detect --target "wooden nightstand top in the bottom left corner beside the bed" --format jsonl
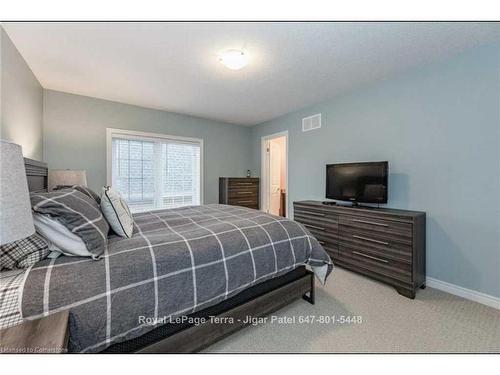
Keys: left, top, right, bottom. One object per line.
{"left": 0, "top": 310, "right": 69, "bottom": 354}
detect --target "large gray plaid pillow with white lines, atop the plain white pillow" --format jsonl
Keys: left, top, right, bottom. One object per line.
{"left": 31, "top": 189, "right": 109, "bottom": 259}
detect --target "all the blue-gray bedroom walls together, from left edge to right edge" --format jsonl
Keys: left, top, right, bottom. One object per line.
{"left": 9, "top": 29, "right": 500, "bottom": 297}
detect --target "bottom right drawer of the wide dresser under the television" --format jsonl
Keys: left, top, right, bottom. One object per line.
{"left": 338, "top": 243, "right": 412, "bottom": 283}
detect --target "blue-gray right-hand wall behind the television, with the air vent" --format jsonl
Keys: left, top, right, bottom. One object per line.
{"left": 252, "top": 45, "right": 500, "bottom": 297}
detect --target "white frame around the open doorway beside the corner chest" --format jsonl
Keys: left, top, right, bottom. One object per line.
{"left": 260, "top": 130, "right": 290, "bottom": 217}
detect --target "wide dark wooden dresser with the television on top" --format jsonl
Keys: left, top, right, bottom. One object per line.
{"left": 293, "top": 201, "right": 425, "bottom": 298}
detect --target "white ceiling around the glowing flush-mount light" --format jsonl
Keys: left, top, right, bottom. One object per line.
{"left": 3, "top": 22, "right": 500, "bottom": 125}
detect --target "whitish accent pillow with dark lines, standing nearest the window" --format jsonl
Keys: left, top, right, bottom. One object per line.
{"left": 101, "top": 186, "right": 134, "bottom": 238}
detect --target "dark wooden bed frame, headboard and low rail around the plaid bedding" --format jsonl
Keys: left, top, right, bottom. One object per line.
{"left": 24, "top": 158, "right": 314, "bottom": 353}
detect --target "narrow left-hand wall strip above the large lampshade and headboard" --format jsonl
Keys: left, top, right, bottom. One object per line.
{"left": 0, "top": 27, "right": 43, "bottom": 160}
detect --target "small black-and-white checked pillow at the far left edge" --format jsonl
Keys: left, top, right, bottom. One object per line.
{"left": 0, "top": 233, "right": 50, "bottom": 270}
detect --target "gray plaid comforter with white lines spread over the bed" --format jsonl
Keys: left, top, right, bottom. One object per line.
{"left": 21, "top": 204, "right": 332, "bottom": 352}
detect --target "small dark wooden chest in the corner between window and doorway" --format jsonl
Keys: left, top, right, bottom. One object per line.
{"left": 219, "top": 177, "right": 259, "bottom": 210}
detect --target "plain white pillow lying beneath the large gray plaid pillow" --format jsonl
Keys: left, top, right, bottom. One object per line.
{"left": 33, "top": 214, "right": 93, "bottom": 257}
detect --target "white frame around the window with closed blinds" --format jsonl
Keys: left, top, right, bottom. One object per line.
{"left": 106, "top": 128, "right": 205, "bottom": 204}
